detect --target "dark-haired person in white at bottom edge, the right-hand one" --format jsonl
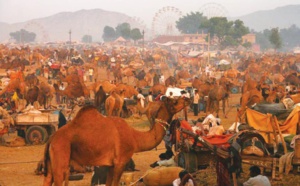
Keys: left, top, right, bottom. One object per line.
{"left": 243, "top": 165, "right": 271, "bottom": 186}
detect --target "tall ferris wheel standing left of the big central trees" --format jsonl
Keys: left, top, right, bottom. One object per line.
{"left": 152, "top": 6, "right": 182, "bottom": 37}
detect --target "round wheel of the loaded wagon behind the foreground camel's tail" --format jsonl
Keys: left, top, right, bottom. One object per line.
{"left": 26, "top": 126, "right": 49, "bottom": 145}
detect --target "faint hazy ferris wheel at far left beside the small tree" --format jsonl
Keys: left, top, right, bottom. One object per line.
{"left": 24, "top": 21, "right": 49, "bottom": 42}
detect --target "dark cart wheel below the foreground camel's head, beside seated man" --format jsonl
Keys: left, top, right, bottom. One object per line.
{"left": 178, "top": 152, "right": 198, "bottom": 173}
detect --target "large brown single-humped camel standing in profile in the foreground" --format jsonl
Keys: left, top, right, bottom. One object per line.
{"left": 44, "top": 98, "right": 190, "bottom": 186}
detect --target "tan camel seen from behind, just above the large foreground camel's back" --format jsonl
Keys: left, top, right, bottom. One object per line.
{"left": 105, "top": 90, "right": 125, "bottom": 117}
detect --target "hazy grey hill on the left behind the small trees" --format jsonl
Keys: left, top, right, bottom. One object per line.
{"left": 0, "top": 9, "right": 146, "bottom": 42}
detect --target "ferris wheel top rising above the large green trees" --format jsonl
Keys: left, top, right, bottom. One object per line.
{"left": 199, "top": 3, "right": 229, "bottom": 19}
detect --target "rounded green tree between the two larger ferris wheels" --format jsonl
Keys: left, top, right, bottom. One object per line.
{"left": 176, "top": 12, "right": 207, "bottom": 34}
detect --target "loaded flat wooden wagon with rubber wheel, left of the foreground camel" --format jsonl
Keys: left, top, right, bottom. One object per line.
{"left": 15, "top": 110, "right": 59, "bottom": 145}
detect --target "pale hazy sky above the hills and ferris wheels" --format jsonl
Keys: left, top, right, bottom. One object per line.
{"left": 0, "top": 0, "right": 300, "bottom": 25}
